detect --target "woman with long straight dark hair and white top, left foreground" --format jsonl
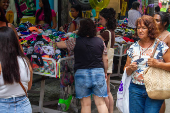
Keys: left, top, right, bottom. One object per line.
{"left": 0, "top": 26, "right": 32, "bottom": 113}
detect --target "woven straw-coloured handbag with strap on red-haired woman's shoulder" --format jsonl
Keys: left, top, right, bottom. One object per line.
{"left": 143, "top": 41, "right": 170, "bottom": 100}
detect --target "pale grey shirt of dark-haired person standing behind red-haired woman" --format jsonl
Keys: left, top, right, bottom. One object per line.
{"left": 128, "top": 9, "right": 141, "bottom": 28}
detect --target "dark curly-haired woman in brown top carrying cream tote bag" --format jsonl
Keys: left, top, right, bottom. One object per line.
{"left": 98, "top": 8, "right": 116, "bottom": 113}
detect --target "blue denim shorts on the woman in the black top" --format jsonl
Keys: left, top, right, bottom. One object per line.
{"left": 74, "top": 68, "right": 108, "bottom": 99}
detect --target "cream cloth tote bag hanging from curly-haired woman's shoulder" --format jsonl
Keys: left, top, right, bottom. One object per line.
{"left": 105, "top": 30, "right": 114, "bottom": 73}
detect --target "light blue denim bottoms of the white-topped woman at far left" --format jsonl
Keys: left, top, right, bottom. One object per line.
{"left": 0, "top": 96, "right": 32, "bottom": 113}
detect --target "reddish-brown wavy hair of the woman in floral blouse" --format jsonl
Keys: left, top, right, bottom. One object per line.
{"left": 135, "top": 15, "right": 159, "bottom": 39}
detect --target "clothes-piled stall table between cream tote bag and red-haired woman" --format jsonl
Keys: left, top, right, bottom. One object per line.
{"left": 112, "top": 18, "right": 135, "bottom": 76}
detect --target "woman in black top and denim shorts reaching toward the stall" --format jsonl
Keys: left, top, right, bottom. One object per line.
{"left": 56, "top": 19, "right": 108, "bottom": 113}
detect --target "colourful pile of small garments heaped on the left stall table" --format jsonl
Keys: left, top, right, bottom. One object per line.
{"left": 16, "top": 22, "right": 76, "bottom": 74}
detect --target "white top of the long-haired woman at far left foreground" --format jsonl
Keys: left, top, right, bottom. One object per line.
{"left": 0, "top": 57, "right": 30, "bottom": 98}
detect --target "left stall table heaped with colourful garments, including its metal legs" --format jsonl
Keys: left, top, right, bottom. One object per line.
{"left": 16, "top": 22, "right": 78, "bottom": 113}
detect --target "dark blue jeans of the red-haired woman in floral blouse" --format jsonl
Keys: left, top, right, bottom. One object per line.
{"left": 129, "top": 83, "right": 164, "bottom": 113}
